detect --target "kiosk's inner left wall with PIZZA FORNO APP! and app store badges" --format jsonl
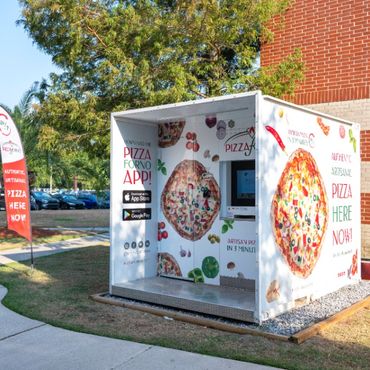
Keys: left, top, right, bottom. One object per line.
{"left": 111, "top": 119, "right": 157, "bottom": 286}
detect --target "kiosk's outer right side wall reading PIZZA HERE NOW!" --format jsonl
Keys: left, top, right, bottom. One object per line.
{"left": 258, "top": 99, "right": 361, "bottom": 320}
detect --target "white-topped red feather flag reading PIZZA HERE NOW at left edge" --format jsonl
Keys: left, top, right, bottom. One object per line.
{"left": 0, "top": 107, "right": 32, "bottom": 242}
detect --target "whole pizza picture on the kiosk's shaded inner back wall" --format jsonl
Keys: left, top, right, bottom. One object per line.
{"left": 161, "top": 160, "right": 220, "bottom": 241}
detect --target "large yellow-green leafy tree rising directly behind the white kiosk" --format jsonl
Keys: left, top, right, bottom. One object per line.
{"left": 20, "top": 0, "right": 303, "bottom": 158}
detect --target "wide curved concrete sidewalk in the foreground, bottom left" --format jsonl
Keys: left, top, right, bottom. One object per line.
{"left": 0, "top": 285, "right": 273, "bottom": 370}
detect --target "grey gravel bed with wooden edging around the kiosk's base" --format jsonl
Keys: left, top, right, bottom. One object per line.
{"left": 103, "top": 280, "right": 370, "bottom": 336}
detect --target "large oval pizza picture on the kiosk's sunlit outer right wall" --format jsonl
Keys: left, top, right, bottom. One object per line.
{"left": 271, "top": 149, "right": 328, "bottom": 278}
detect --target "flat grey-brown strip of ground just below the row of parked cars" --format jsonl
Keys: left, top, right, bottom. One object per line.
{"left": 0, "top": 209, "right": 109, "bottom": 228}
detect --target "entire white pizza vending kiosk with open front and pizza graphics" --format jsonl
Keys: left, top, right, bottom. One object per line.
{"left": 110, "top": 92, "right": 361, "bottom": 322}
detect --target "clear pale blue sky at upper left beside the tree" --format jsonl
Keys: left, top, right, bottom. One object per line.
{"left": 0, "top": 0, "right": 58, "bottom": 109}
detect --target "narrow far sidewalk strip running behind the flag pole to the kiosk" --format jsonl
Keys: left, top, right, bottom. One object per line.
{"left": 0, "top": 233, "right": 109, "bottom": 265}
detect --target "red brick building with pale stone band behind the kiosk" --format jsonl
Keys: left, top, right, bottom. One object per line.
{"left": 261, "top": 0, "right": 370, "bottom": 258}
